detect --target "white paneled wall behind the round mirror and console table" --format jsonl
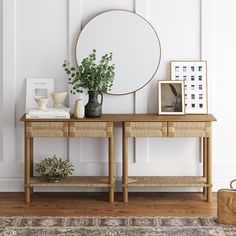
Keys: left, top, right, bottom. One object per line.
{"left": 0, "top": 0, "right": 236, "bottom": 191}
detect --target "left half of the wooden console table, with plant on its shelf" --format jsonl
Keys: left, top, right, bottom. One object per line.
{"left": 20, "top": 116, "right": 114, "bottom": 203}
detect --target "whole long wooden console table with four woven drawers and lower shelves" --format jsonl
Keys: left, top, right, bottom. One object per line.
{"left": 20, "top": 114, "right": 216, "bottom": 203}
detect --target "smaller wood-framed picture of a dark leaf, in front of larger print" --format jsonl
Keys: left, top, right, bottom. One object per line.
{"left": 158, "top": 80, "right": 185, "bottom": 115}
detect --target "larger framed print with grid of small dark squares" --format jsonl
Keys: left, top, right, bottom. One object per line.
{"left": 170, "top": 61, "right": 208, "bottom": 114}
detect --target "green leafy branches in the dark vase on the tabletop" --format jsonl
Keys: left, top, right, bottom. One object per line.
{"left": 63, "top": 49, "right": 115, "bottom": 94}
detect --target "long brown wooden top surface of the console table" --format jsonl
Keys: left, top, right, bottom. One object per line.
{"left": 20, "top": 114, "right": 216, "bottom": 122}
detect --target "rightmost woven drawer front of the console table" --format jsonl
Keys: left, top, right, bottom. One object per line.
{"left": 168, "top": 122, "right": 211, "bottom": 137}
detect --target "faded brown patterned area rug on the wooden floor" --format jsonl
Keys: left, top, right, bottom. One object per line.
{"left": 0, "top": 217, "right": 236, "bottom": 236}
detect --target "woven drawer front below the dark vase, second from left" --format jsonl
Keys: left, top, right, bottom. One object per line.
{"left": 69, "top": 122, "right": 113, "bottom": 137}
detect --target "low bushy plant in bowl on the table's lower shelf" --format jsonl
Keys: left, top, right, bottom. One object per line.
{"left": 36, "top": 155, "right": 74, "bottom": 182}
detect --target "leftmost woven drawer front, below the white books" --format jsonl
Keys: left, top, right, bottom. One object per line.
{"left": 26, "top": 122, "right": 68, "bottom": 137}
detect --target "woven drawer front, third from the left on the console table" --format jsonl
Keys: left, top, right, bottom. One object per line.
{"left": 125, "top": 122, "right": 167, "bottom": 137}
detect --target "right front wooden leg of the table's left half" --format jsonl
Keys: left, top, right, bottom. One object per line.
{"left": 108, "top": 133, "right": 114, "bottom": 202}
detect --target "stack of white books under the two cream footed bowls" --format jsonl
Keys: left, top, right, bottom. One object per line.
{"left": 26, "top": 108, "right": 70, "bottom": 119}
